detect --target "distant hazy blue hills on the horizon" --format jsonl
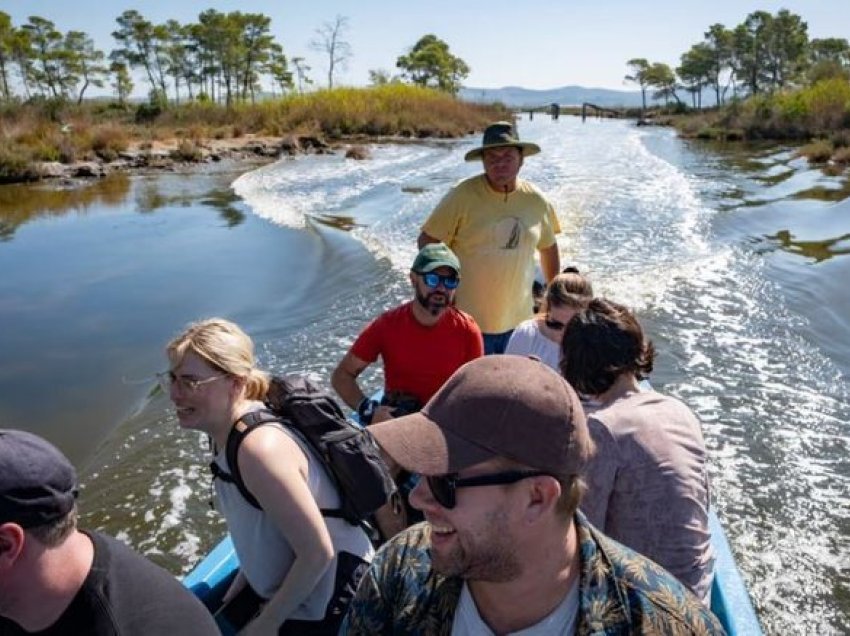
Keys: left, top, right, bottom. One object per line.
{"left": 460, "top": 86, "right": 651, "bottom": 108}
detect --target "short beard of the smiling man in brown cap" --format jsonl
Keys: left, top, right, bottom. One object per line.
{"left": 431, "top": 512, "right": 522, "bottom": 583}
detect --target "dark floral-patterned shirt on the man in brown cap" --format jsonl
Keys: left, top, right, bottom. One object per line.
{"left": 340, "top": 512, "right": 726, "bottom": 636}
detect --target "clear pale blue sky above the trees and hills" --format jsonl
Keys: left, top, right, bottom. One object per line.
{"left": 6, "top": 0, "right": 850, "bottom": 90}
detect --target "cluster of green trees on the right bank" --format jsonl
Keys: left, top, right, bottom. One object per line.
{"left": 625, "top": 9, "right": 850, "bottom": 109}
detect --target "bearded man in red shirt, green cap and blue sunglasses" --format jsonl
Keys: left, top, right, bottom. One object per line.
{"left": 331, "top": 243, "right": 483, "bottom": 424}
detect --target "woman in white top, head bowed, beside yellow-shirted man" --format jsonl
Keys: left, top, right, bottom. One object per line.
{"left": 505, "top": 267, "right": 593, "bottom": 371}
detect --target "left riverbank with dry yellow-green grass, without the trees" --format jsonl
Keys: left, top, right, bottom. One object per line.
{"left": 0, "top": 84, "right": 508, "bottom": 183}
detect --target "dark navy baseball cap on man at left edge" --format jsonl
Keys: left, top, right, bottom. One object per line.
{"left": 0, "top": 429, "right": 77, "bottom": 528}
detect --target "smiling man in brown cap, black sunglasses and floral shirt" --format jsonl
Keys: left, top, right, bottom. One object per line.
{"left": 340, "top": 355, "right": 724, "bottom": 636}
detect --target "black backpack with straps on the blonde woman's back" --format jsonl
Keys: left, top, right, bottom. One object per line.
{"left": 210, "top": 375, "right": 396, "bottom": 525}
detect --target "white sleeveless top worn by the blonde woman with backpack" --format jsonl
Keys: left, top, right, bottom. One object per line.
{"left": 213, "top": 424, "right": 374, "bottom": 620}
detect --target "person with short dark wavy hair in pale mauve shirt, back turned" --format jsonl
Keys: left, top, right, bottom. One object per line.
{"left": 561, "top": 298, "right": 714, "bottom": 604}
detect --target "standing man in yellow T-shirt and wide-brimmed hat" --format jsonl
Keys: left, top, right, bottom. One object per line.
{"left": 419, "top": 121, "right": 561, "bottom": 354}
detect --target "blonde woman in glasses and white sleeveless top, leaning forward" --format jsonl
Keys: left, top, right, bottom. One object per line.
{"left": 162, "top": 318, "right": 373, "bottom": 635}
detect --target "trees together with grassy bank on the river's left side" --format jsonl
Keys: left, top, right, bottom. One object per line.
{"left": 0, "top": 9, "right": 484, "bottom": 181}
